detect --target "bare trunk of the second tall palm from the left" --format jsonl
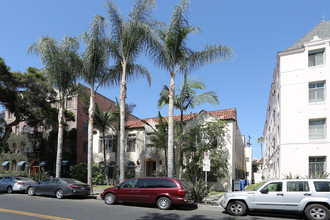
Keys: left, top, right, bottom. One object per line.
{"left": 87, "top": 85, "right": 95, "bottom": 192}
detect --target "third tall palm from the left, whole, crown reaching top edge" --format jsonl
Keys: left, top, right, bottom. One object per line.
{"left": 106, "top": 0, "right": 155, "bottom": 182}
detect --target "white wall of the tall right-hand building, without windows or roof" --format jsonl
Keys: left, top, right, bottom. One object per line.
{"left": 264, "top": 37, "right": 330, "bottom": 179}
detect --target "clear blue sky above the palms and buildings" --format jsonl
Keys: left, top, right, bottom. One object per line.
{"left": 0, "top": 0, "right": 330, "bottom": 158}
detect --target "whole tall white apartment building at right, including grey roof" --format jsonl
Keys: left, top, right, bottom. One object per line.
{"left": 263, "top": 20, "right": 330, "bottom": 180}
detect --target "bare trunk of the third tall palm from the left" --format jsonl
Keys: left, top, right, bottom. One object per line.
{"left": 119, "top": 61, "right": 126, "bottom": 182}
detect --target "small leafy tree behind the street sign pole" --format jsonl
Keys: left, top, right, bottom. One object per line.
{"left": 182, "top": 119, "right": 229, "bottom": 198}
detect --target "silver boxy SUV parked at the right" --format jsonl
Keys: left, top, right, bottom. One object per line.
{"left": 220, "top": 179, "right": 330, "bottom": 220}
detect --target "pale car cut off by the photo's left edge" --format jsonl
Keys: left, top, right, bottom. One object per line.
{"left": 0, "top": 176, "right": 35, "bottom": 193}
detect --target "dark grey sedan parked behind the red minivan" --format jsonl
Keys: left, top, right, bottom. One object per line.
{"left": 27, "top": 178, "right": 90, "bottom": 199}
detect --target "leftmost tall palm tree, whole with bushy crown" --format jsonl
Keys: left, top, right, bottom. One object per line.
{"left": 28, "top": 36, "right": 81, "bottom": 178}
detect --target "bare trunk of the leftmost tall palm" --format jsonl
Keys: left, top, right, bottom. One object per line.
{"left": 56, "top": 103, "right": 64, "bottom": 178}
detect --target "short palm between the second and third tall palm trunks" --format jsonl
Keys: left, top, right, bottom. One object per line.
{"left": 94, "top": 104, "right": 116, "bottom": 185}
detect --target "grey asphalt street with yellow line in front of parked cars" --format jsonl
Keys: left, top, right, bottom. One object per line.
{"left": 0, "top": 193, "right": 303, "bottom": 220}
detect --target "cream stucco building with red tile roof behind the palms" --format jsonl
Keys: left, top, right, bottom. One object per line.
{"left": 93, "top": 108, "right": 248, "bottom": 191}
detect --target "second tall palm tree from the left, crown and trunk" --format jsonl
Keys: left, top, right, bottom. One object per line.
{"left": 82, "top": 15, "right": 116, "bottom": 187}
